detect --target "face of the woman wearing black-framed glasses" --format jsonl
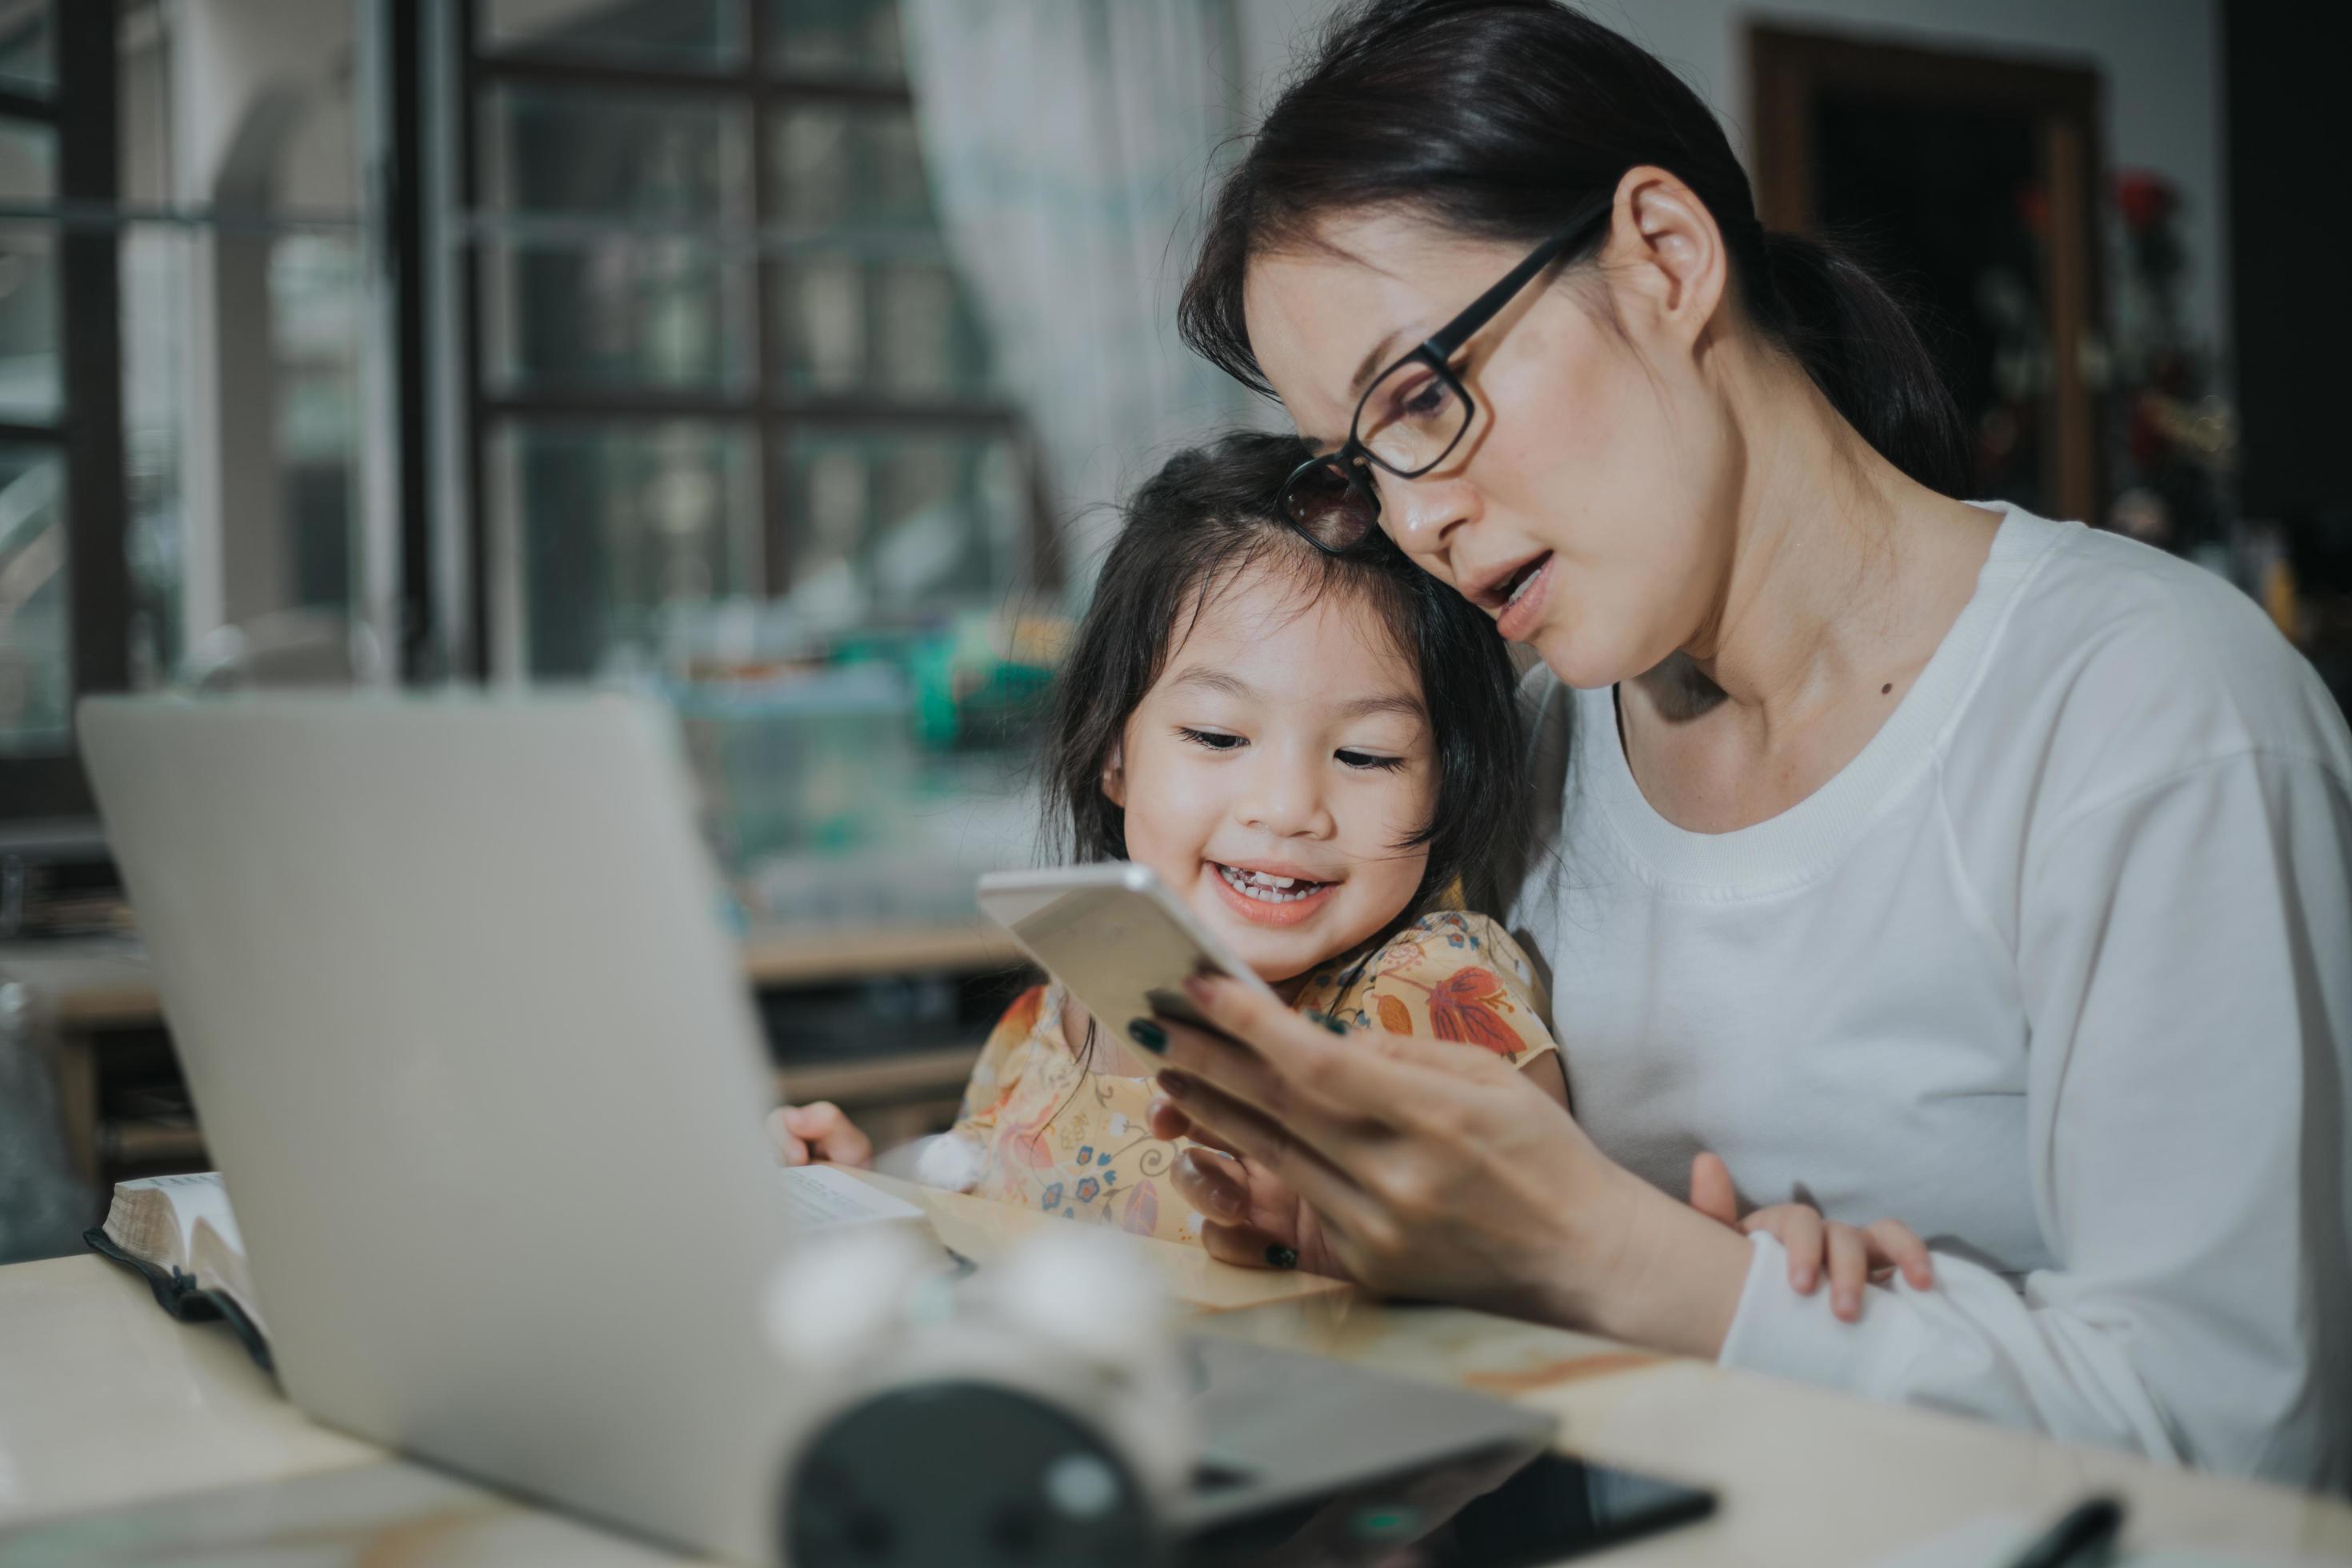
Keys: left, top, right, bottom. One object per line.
{"left": 1244, "top": 214, "right": 1738, "bottom": 686}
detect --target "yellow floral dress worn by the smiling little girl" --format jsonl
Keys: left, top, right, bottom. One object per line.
{"left": 953, "top": 910, "right": 1554, "bottom": 1242}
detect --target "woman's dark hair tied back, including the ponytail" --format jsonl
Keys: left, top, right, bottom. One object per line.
{"left": 1178, "top": 0, "right": 1974, "bottom": 496}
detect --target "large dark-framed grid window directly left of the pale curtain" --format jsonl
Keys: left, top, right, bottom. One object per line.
{"left": 456, "top": 0, "right": 1038, "bottom": 679}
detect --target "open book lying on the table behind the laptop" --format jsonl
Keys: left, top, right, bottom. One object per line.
{"left": 82, "top": 1166, "right": 926, "bottom": 1366}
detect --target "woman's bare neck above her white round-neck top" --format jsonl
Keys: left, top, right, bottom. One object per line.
{"left": 1623, "top": 345, "right": 1999, "bottom": 832}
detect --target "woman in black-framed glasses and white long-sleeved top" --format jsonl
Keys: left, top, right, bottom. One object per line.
{"left": 1134, "top": 0, "right": 2352, "bottom": 1486}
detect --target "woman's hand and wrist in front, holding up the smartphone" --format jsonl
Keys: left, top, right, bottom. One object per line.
{"left": 1138, "top": 978, "right": 1747, "bottom": 1357}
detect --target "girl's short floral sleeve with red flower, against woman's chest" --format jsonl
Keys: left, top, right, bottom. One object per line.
{"left": 1336, "top": 912, "right": 1557, "bottom": 1067}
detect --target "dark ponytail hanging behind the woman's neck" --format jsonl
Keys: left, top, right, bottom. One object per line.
{"left": 1745, "top": 230, "right": 1976, "bottom": 496}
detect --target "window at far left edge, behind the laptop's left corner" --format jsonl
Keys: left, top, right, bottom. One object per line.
{"left": 0, "top": 0, "right": 376, "bottom": 818}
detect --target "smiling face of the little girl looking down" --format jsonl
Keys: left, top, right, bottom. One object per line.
{"left": 1103, "top": 566, "right": 1437, "bottom": 980}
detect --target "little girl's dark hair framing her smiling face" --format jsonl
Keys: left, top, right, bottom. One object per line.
{"left": 1042, "top": 433, "right": 1526, "bottom": 912}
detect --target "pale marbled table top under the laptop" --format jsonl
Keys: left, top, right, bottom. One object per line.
{"left": 0, "top": 1170, "right": 2352, "bottom": 1566}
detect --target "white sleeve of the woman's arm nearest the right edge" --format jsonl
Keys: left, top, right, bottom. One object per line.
{"left": 1722, "top": 752, "right": 2352, "bottom": 1490}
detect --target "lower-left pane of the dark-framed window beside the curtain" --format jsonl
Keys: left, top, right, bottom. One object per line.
{"left": 491, "top": 421, "right": 760, "bottom": 677}
